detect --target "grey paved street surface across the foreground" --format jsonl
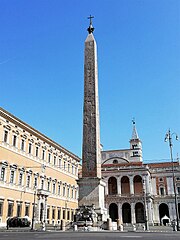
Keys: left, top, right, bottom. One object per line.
{"left": 0, "top": 232, "right": 180, "bottom": 240}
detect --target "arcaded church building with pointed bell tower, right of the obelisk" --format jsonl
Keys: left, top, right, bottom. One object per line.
{"left": 101, "top": 123, "right": 180, "bottom": 225}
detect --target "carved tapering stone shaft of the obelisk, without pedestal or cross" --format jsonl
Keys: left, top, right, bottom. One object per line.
{"left": 82, "top": 35, "right": 101, "bottom": 177}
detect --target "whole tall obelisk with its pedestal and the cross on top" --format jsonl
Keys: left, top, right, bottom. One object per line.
{"left": 78, "top": 15, "right": 107, "bottom": 220}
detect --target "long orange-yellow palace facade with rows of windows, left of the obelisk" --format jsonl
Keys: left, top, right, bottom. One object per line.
{"left": 0, "top": 108, "right": 80, "bottom": 226}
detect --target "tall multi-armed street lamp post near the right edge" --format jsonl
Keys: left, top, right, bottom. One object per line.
{"left": 164, "top": 129, "right": 180, "bottom": 231}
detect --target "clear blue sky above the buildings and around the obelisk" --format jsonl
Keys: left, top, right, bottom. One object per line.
{"left": 0, "top": 0, "right": 180, "bottom": 161}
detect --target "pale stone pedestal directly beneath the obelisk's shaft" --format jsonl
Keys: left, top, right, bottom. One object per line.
{"left": 78, "top": 177, "right": 108, "bottom": 221}
